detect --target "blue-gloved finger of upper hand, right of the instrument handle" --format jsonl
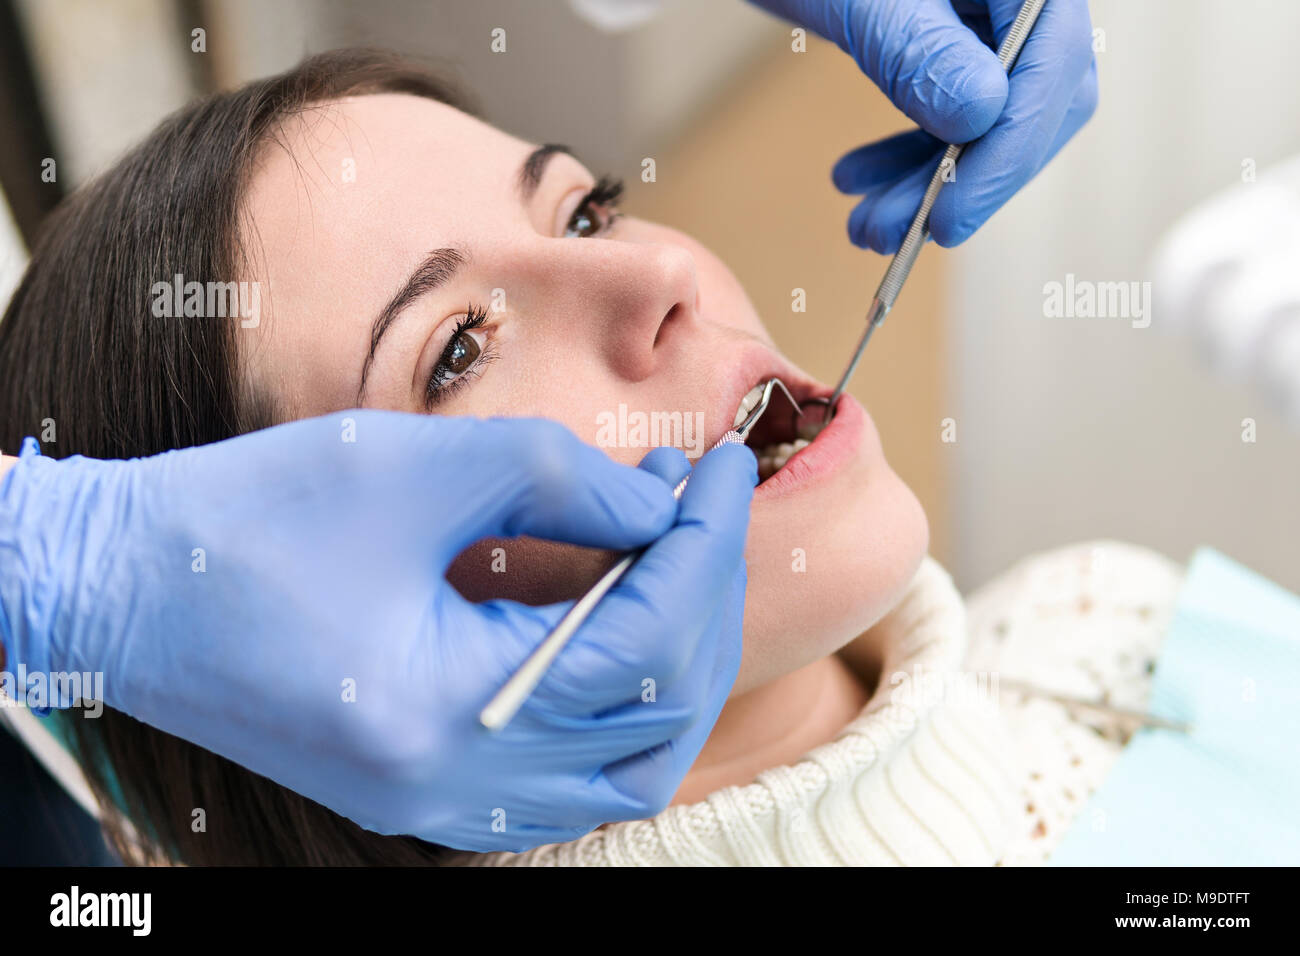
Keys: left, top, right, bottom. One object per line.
{"left": 930, "top": 0, "right": 1096, "bottom": 246}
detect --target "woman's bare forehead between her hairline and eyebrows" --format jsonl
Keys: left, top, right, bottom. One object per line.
{"left": 239, "top": 94, "right": 532, "bottom": 416}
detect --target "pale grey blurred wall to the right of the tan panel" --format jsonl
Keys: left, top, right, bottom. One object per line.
{"left": 941, "top": 0, "right": 1300, "bottom": 589}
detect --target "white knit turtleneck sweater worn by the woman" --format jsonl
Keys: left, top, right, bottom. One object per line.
{"left": 454, "top": 542, "right": 1182, "bottom": 866}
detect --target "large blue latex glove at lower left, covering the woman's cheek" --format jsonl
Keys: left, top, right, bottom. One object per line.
{"left": 0, "top": 411, "right": 757, "bottom": 851}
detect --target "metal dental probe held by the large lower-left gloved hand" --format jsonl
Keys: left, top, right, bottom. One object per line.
{"left": 478, "top": 378, "right": 802, "bottom": 731}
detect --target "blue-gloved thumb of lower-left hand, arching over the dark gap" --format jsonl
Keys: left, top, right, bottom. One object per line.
{"left": 430, "top": 419, "right": 677, "bottom": 570}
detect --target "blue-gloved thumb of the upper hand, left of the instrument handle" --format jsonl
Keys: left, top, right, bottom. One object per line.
{"left": 753, "top": 0, "right": 1008, "bottom": 143}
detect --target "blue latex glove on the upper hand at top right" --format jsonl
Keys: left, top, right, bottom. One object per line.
{"left": 753, "top": 0, "right": 1097, "bottom": 255}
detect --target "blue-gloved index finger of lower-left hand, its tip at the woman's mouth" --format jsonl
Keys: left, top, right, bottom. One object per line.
{"left": 522, "top": 445, "right": 758, "bottom": 714}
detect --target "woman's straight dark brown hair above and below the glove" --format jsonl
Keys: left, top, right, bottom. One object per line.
{"left": 0, "top": 49, "right": 476, "bottom": 865}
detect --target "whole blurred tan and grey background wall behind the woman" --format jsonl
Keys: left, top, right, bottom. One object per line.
{"left": 0, "top": 0, "right": 1300, "bottom": 588}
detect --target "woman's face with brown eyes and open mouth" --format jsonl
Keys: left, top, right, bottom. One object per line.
{"left": 241, "top": 94, "right": 928, "bottom": 695}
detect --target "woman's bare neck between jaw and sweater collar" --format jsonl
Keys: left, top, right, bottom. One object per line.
{"left": 672, "top": 654, "right": 870, "bottom": 804}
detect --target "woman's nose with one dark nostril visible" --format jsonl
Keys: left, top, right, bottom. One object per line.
{"left": 535, "top": 239, "right": 699, "bottom": 381}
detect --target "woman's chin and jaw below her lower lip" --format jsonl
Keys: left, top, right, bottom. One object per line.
{"left": 732, "top": 466, "right": 930, "bottom": 696}
